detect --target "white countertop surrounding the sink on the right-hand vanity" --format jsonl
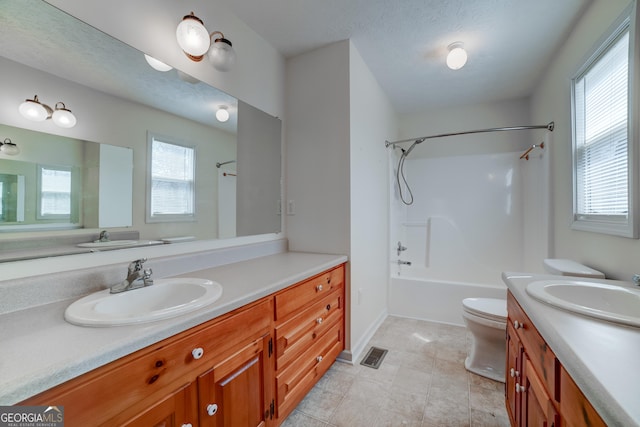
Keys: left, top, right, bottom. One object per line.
{"left": 503, "top": 272, "right": 640, "bottom": 427}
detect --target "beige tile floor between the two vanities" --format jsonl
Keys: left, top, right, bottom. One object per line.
{"left": 282, "top": 316, "right": 509, "bottom": 427}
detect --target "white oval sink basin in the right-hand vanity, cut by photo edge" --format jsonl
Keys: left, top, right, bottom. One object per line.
{"left": 527, "top": 280, "right": 640, "bottom": 327}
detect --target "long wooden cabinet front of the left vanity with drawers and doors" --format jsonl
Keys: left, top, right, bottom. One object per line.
{"left": 20, "top": 265, "right": 344, "bottom": 427}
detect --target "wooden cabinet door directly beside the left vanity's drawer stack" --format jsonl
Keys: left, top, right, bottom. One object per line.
{"left": 198, "top": 334, "right": 274, "bottom": 427}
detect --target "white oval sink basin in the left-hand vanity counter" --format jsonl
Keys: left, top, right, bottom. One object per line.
{"left": 64, "top": 278, "right": 222, "bottom": 326}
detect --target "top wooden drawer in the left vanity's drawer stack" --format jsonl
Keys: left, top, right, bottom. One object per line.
{"left": 275, "top": 265, "right": 344, "bottom": 320}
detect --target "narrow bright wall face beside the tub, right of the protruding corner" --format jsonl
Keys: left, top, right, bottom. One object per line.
{"left": 349, "top": 45, "right": 397, "bottom": 356}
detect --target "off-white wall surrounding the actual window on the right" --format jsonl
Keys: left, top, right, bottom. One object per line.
{"left": 531, "top": 0, "right": 640, "bottom": 280}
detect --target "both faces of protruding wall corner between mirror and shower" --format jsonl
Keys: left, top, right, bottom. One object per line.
{"left": 286, "top": 41, "right": 396, "bottom": 358}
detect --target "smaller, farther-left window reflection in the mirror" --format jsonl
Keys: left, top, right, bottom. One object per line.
{"left": 38, "top": 165, "right": 71, "bottom": 219}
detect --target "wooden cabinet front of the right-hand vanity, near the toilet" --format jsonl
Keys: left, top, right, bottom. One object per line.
{"left": 505, "top": 292, "right": 606, "bottom": 427}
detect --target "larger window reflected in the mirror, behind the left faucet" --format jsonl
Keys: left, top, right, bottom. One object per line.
{"left": 147, "top": 135, "right": 195, "bottom": 222}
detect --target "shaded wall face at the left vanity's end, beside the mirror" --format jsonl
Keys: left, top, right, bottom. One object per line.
{"left": 285, "top": 41, "right": 350, "bottom": 254}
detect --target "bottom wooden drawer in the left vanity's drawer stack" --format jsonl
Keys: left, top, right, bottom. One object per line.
{"left": 276, "top": 325, "right": 344, "bottom": 419}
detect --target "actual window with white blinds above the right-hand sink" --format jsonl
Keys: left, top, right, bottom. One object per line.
{"left": 572, "top": 6, "right": 636, "bottom": 237}
